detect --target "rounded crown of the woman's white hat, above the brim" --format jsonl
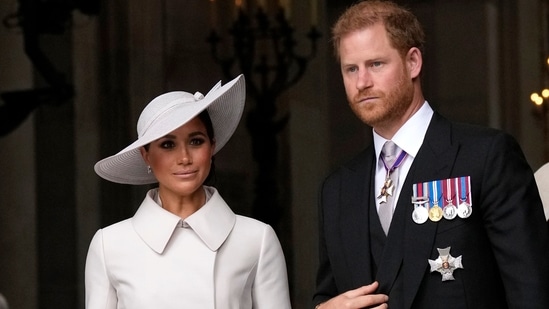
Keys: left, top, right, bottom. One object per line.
{"left": 137, "top": 91, "right": 204, "bottom": 137}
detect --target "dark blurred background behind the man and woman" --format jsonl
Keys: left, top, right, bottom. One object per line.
{"left": 0, "top": 0, "right": 549, "bottom": 309}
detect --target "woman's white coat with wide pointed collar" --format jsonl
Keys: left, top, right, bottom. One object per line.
{"left": 85, "top": 186, "right": 291, "bottom": 309}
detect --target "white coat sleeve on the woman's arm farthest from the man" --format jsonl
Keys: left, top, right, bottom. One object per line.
{"left": 85, "top": 230, "right": 117, "bottom": 309}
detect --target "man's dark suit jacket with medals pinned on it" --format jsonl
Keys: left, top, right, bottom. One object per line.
{"left": 313, "top": 113, "right": 549, "bottom": 309}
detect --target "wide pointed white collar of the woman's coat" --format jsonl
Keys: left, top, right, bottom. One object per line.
{"left": 132, "top": 186, "right": 236, "bottom": 254}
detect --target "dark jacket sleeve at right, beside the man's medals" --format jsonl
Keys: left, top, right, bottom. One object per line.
{"left": 480, "top": 133, "right": 549, "bottom": 308}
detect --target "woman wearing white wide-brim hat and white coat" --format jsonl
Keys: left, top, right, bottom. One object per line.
{"left": 85, "top": 75, "right": 290, "bottom": 309}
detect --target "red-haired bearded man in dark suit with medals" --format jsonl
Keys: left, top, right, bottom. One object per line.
{"left": 313, "top": 1, "right": 549, "bottom": 309}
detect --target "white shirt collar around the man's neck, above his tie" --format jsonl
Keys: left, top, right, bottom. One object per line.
{"left": 372, "top": 101, "right": 434, "bottom": 158}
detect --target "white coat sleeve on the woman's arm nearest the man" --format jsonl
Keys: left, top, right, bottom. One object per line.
{"left": 252, "top": 225, "right": 291, "bottom": 309}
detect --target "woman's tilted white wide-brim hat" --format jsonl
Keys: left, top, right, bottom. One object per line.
{"left": 94, "top": 74, "right": 246, "bottom": 185}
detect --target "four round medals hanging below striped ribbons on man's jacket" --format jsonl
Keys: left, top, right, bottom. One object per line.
{"left": 412, "top": 196, "right": 473, "bottom": 224}
